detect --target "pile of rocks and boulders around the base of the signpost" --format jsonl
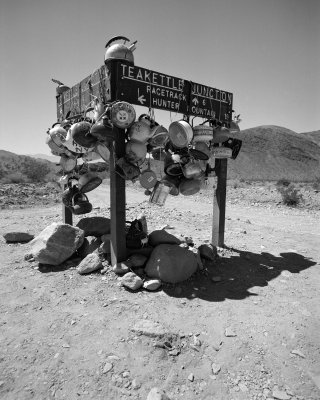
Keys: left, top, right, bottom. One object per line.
{"left": 20, "top": 217, "right": 216, "bottom": 291}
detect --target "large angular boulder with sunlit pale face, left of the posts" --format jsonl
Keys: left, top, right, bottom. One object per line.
{"left": 29, "top": 222, "right": 84, "bottom": 265}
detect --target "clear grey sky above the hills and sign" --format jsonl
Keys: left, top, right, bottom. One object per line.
{"left": 0, "top": 0, "right": 320, "bottom": 155}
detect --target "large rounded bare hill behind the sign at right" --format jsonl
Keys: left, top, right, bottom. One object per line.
{"left": 228, "top": 125, "right": 320, "bottom": 182}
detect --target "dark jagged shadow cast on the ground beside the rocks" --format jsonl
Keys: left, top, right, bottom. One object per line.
{"left": 162, "top": 248, "right": 316, "bottom": 301}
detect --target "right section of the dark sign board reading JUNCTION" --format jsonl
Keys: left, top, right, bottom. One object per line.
{"left": 189, "top": 82, "right": 233, "bottom": 122}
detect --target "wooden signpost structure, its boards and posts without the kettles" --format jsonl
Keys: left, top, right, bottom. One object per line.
{"left": 57, "top": 60, "right": 233, "bottom": 264}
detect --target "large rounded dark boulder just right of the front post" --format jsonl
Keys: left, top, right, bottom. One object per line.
{"left": 145, "top": 244, "right": 197, "bottom": 283}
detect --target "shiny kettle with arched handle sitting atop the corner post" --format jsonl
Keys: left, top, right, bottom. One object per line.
{"left": 104, "top": 36, "right": 137, "bottom": 65}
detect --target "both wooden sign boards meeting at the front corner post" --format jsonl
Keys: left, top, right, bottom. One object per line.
{"left": 57, "top": 61, "right": 233, "bottom": 123}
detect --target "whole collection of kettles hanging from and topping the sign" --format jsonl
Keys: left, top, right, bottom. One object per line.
{"left": 46, "top": 36, "right": 242, "bottom": 214}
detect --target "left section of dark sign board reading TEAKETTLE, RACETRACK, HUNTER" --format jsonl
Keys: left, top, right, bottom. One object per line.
{"left": 117, "top": 63, "right": 190, "bottom": 114}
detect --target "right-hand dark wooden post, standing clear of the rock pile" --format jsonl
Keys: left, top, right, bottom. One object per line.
{"left": 211, "top": 158, "right": 228, "bottom": 247}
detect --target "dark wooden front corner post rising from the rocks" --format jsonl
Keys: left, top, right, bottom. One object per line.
{"left": 109, "top": 61, "right": 127, "bottom": 265}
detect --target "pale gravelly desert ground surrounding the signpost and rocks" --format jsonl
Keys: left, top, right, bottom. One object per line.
{"left": 0, "top": 182, "right": 320, "bottom": 400}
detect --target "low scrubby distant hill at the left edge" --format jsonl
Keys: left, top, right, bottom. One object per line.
{"left": 0, "top": 150, "right": 60, "bottom": 183}
